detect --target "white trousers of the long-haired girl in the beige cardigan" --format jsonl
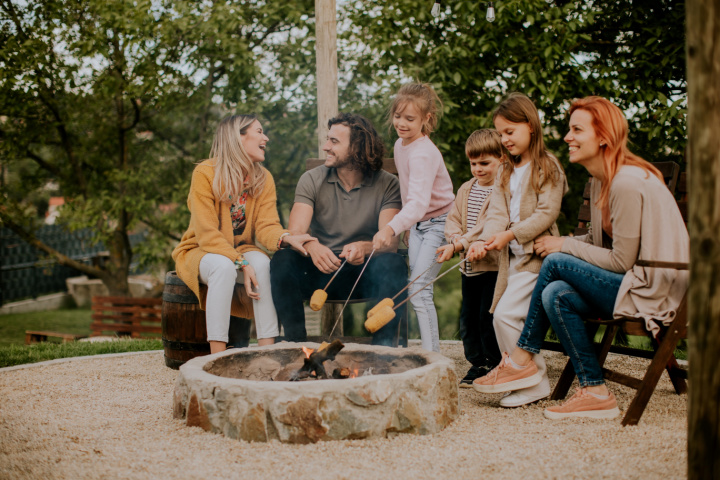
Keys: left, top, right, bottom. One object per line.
{"left": 493, "top": 253, "right": 550, "bottom": 396}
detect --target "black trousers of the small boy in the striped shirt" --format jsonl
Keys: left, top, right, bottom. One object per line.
{"left": 460, "top": 272, "right": 502, "bottom": 368}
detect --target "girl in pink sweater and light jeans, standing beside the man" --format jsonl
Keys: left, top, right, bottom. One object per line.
{"left": 373, "top": 83, "right": 455, "bottom": 352}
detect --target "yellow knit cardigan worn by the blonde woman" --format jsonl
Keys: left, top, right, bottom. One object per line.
{"left": 172, "top": 159, "right": 287, "bottom": 318}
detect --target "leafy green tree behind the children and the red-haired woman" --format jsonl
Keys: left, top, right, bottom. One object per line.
{"left": 340, "top": 0, "right": 686, "bottom": 231}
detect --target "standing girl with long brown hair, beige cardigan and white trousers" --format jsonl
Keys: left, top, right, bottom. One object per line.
{"left": 467, "top": 93, "right": 567, "bottom": 407}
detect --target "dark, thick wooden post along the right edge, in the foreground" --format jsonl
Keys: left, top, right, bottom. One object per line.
{"left": 685, "top": 0, "right": 720, "bottom": 479}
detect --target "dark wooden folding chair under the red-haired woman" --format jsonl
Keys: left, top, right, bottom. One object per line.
{"left": 550, "top": 162, "right": 688, "bottom": 425}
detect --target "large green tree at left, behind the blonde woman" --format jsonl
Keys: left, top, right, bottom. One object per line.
{"left": 0, "top": 0, "right": 313, "bottom": 294}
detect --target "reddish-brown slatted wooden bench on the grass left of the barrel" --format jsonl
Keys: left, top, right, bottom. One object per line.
{"left": 90, "top": 297, "right": 162, "bottom": 338}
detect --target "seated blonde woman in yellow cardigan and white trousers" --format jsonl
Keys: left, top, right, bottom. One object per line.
{"left": 172, "top": 115, "right": 313, "bottom": 353}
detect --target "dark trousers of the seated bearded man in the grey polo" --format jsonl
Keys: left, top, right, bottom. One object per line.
{"left": 270, "top": 249, "right": 408, "bottom": 345}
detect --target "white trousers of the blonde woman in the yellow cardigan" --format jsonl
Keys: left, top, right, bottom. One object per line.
{"left": 200, "top": 252, "right": 280, "bottom": 343}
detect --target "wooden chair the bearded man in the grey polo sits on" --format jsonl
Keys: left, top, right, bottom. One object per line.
{"left": 305, "top": 158, "right": 408, "bottom": 347}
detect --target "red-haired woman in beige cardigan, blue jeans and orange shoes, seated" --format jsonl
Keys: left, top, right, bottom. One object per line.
{"left": 472, "top": 97, "right": 689, "bottom": 419}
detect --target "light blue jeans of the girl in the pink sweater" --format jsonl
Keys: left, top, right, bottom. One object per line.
{"left": 408, "top": 214, "right": 447, "bottom": 352}
